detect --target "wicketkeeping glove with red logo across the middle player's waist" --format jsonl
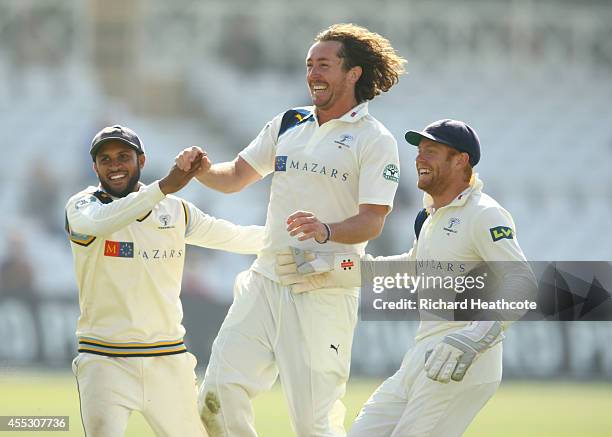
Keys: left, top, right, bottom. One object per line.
{"left": 276, "top": 247, "right": 361, "bottom": 293}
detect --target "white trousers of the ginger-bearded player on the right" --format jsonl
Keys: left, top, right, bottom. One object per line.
{"left": 348, "top": 335, "right": 502, "bottom": 437}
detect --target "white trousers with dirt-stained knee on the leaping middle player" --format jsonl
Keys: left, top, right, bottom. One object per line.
{"left": 199, "top": 271, "right": 357, "bottom": 437}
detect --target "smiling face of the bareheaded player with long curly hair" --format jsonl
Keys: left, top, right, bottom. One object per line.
{"left": 306, "top": 41, "right": 361, "bottom": 112}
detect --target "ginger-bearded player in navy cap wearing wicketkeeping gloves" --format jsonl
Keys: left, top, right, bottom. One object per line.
{"left": 348, "top": 119, "right": 536, "bottom": 437}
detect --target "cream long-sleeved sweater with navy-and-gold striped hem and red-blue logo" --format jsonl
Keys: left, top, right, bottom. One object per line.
{"left": 66, "top": 182, "right": 263, "bottom": 356}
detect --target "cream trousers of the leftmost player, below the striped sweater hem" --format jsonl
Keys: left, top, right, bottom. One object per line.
{"left": 72, "top": 352, "right": 207, "bottom": 437}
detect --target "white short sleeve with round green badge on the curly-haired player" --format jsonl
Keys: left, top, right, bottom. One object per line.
{"left": 359, "top": 133, "right": 400, "bottom": 207}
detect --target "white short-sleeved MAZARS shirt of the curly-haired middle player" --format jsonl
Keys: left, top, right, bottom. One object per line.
{"left": 239, "top": 102, "right": 399, "bottom": 281}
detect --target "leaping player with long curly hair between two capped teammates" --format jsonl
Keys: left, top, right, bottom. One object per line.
{"left": 177, "top": 24, "right": 405, "bottom": 437}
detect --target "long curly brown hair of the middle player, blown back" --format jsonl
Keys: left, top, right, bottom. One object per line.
{"left": 314, "top": 23, "right": 406, "bottom": 103}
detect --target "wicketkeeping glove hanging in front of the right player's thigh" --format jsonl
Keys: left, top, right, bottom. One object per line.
{"left": 425, "top": 321, "right": 503, "bottom": 383}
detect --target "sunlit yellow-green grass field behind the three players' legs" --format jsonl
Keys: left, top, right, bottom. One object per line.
{"left": 0, "top": 373, "right": 612, "bottom": 437}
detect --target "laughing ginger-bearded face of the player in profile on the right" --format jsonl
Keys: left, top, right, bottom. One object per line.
{"left": 415, "top": 138, "right": 467, "bottom": 196}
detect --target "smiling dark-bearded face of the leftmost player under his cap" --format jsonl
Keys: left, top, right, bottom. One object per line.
{"left": 93, "top": 141, "right": 145, "bottom": 197}
